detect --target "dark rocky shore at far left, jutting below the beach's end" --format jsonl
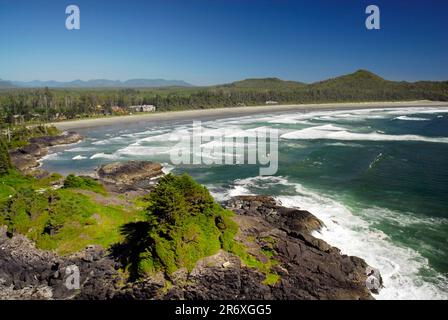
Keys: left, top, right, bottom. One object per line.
{"left": 9, "top": 132, "right": 82, "bottom": 175}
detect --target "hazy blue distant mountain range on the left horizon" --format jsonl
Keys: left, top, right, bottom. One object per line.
{"left": 0, "top": 79, "right": 192, "bottom": 88}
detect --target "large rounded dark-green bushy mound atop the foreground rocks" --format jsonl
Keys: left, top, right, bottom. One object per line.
{"left": 123, "top": 174, "right": 237, "bottom": 275}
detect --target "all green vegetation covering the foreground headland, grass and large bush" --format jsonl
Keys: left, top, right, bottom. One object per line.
{"left": 0, "top": 170, "right": 279, "bottom": 285}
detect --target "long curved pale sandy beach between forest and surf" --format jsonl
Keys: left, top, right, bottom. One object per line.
{"left": 49, "top": 100, "right": 448, "bottom": 130}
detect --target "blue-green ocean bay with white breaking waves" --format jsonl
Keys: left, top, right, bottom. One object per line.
{"left": 42, "top": 107, "right": 448, "bottom": 299}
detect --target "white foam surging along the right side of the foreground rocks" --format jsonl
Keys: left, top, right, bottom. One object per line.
{"left": 221, "top": 177, "right": 448, "bottom": 299}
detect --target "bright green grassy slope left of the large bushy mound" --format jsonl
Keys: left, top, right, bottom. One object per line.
{"left": 0, "top": 171, "right": 143, "bottom": 255}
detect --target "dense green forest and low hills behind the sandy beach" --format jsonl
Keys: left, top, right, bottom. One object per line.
{"left": 0, "top": 70, "right": 448, "bottom": 125}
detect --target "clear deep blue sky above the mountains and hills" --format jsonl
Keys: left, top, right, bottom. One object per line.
{"left": 0, "top": 0, "right": 448, "bottom": 85}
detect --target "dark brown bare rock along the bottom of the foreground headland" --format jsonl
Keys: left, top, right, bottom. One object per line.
{"left": 0, "top": 194, "right": 380, "bottom": 300}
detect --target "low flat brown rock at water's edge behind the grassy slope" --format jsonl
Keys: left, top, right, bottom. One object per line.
{"left": 97, "top": 161, "right": 164, "bottom": 190}
